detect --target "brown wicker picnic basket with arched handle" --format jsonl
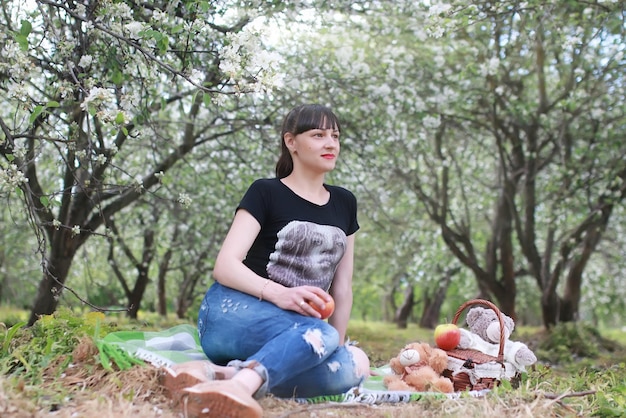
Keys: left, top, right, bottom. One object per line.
{"left": 443, "top": 299, "right": 519, "bottom": 392}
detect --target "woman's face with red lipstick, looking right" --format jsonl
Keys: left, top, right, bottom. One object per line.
{"left": 285, "top": 128, "right": 340, "bottom": 173}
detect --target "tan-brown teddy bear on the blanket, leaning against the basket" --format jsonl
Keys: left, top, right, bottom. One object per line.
{"left": 383, "top": 342, "right": 454, "bottom": 393}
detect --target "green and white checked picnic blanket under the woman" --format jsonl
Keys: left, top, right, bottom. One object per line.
{"left": 98, "top": 324, "right": 489, "bottom": 404}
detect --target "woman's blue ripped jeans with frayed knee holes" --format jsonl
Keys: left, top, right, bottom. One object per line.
{"left": 198, "top": 282, "right": 363, "bottom": 398}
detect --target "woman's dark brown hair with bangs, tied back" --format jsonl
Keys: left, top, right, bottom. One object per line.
{"left": 276, "top": 104, "right": 341, "bottom": 178}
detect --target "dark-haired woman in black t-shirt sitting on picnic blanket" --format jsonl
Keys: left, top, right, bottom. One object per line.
{"left": 164, "top": 105, "right": 369, "bottom": 417}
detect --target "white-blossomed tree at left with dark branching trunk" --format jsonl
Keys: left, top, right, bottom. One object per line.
{"left": 0, "top": 0, "right": 277, "bottom": 323}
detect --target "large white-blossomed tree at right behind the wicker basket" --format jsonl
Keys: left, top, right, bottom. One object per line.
{"left": 274, "top": 0, "right": 626, "bottom": 326}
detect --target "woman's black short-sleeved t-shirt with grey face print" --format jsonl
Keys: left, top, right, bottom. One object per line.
{"left": 237, "top": 178, "right": 359, "bottom": 290}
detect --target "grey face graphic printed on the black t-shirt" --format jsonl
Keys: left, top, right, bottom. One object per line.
{"left": 267, "top": 221, "right": 346, "bottom": 290}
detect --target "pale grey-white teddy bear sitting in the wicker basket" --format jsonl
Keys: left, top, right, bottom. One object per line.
{"left": 457, "top": 307, "right": 537, "bottom": 372}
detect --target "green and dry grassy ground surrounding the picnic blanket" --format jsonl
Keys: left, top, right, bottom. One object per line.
{"left": 0, "top": 311, "right": 626, "bottom": 418}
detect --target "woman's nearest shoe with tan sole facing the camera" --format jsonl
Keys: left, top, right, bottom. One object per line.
{"left": 180, "top": 380, "right": 263, "bottom": 418}
